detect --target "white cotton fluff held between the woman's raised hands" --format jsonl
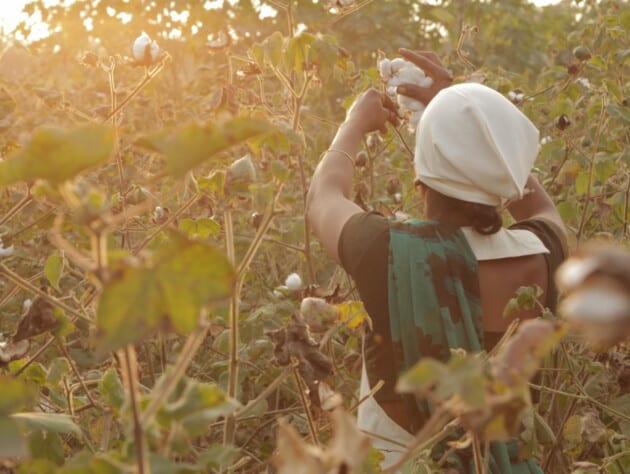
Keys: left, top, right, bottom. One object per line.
{"left": 378, "top": 58, "right": 433, "bottom": 131}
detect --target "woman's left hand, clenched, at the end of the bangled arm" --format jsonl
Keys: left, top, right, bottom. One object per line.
{"left": 344, "top": 88, "right": 399, "bottom": 134}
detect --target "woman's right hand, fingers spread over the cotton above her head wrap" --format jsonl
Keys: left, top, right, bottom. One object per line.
{"left": 396, "top": 48, "right": 453, "bottom": 105}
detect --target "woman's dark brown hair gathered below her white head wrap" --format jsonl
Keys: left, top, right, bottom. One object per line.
{"left": 417, "top": 183, "right": 503, "bottom": 235}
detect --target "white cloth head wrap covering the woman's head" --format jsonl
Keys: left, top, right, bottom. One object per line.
{"left": 414, "top": 83, "right": 539, "bottom": 206}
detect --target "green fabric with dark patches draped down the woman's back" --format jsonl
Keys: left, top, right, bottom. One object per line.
{"left": 388, "top": 220, "right": 543, "bottom": 474}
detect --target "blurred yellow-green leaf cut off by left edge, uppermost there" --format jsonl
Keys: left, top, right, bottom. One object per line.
{"left": 0, "top": 125, "right": 114, "bottom": 186}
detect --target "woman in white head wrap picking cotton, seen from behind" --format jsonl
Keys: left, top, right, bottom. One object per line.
{"left": 307, "top": 49, "right": 566, "bottom": 473}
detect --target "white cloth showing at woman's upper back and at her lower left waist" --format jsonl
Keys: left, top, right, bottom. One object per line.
{"left": 357, "top": 227, "right": 549, "bottom": 469}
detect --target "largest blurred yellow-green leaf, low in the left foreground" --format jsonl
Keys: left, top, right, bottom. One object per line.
{"left": 97, "top": 232, "right": 234, "bottom": 354}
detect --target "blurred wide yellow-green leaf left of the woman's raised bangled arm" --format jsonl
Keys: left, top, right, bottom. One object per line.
{"left": 137, "top": 117, "right": 274, "bottom": 177}
